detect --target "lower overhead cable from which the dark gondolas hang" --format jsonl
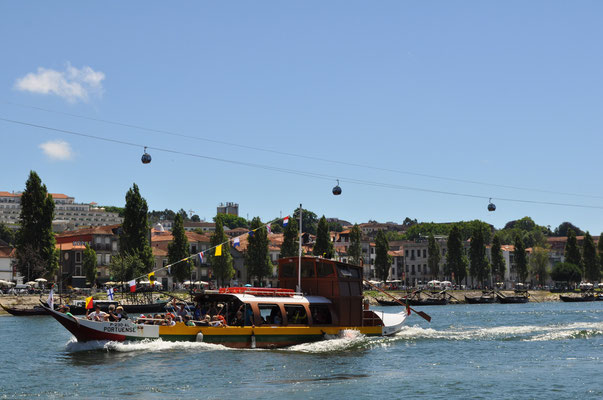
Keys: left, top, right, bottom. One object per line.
{"left": 0, "top": 117, "right": 603, "bottom": 209}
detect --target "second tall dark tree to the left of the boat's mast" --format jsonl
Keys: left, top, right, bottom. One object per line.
{"left": 245, "top": 217, "right": 274, "bottom": 285}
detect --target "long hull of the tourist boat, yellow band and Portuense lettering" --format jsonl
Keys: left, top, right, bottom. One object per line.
{"left": 46, "top": 308, "right": 406, "bottom": 349}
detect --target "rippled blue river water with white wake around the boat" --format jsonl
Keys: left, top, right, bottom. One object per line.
{"left": 0, "top": 302, "right": 603, "bottom": 399}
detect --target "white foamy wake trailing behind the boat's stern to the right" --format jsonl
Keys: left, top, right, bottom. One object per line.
{"left": 392, "top": 322, "right": 603, "bottom": 341}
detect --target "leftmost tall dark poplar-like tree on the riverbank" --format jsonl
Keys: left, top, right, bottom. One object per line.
{"left": 15, "top": 171, "right": 59, "bottom": 280}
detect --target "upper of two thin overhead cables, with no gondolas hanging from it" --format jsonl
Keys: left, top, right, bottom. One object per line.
{"left": 1, "top": 100, "right": 603, "bottom": 199}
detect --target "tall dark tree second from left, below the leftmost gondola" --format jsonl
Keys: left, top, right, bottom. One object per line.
{"left": 119, "top": 184, "right": 154, "bottom": 273}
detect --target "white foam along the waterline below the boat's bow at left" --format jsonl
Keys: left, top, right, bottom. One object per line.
{"left": 66, "top": 338, "right": 230, "bottom": 353}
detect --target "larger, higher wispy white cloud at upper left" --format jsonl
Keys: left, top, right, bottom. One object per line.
{"left": 15, "top": 63, "right": 105, "bottom": 103}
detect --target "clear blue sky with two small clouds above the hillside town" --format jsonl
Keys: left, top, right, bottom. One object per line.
{"left": 0, "top": 0, "right": 603, "bottom": 231}
